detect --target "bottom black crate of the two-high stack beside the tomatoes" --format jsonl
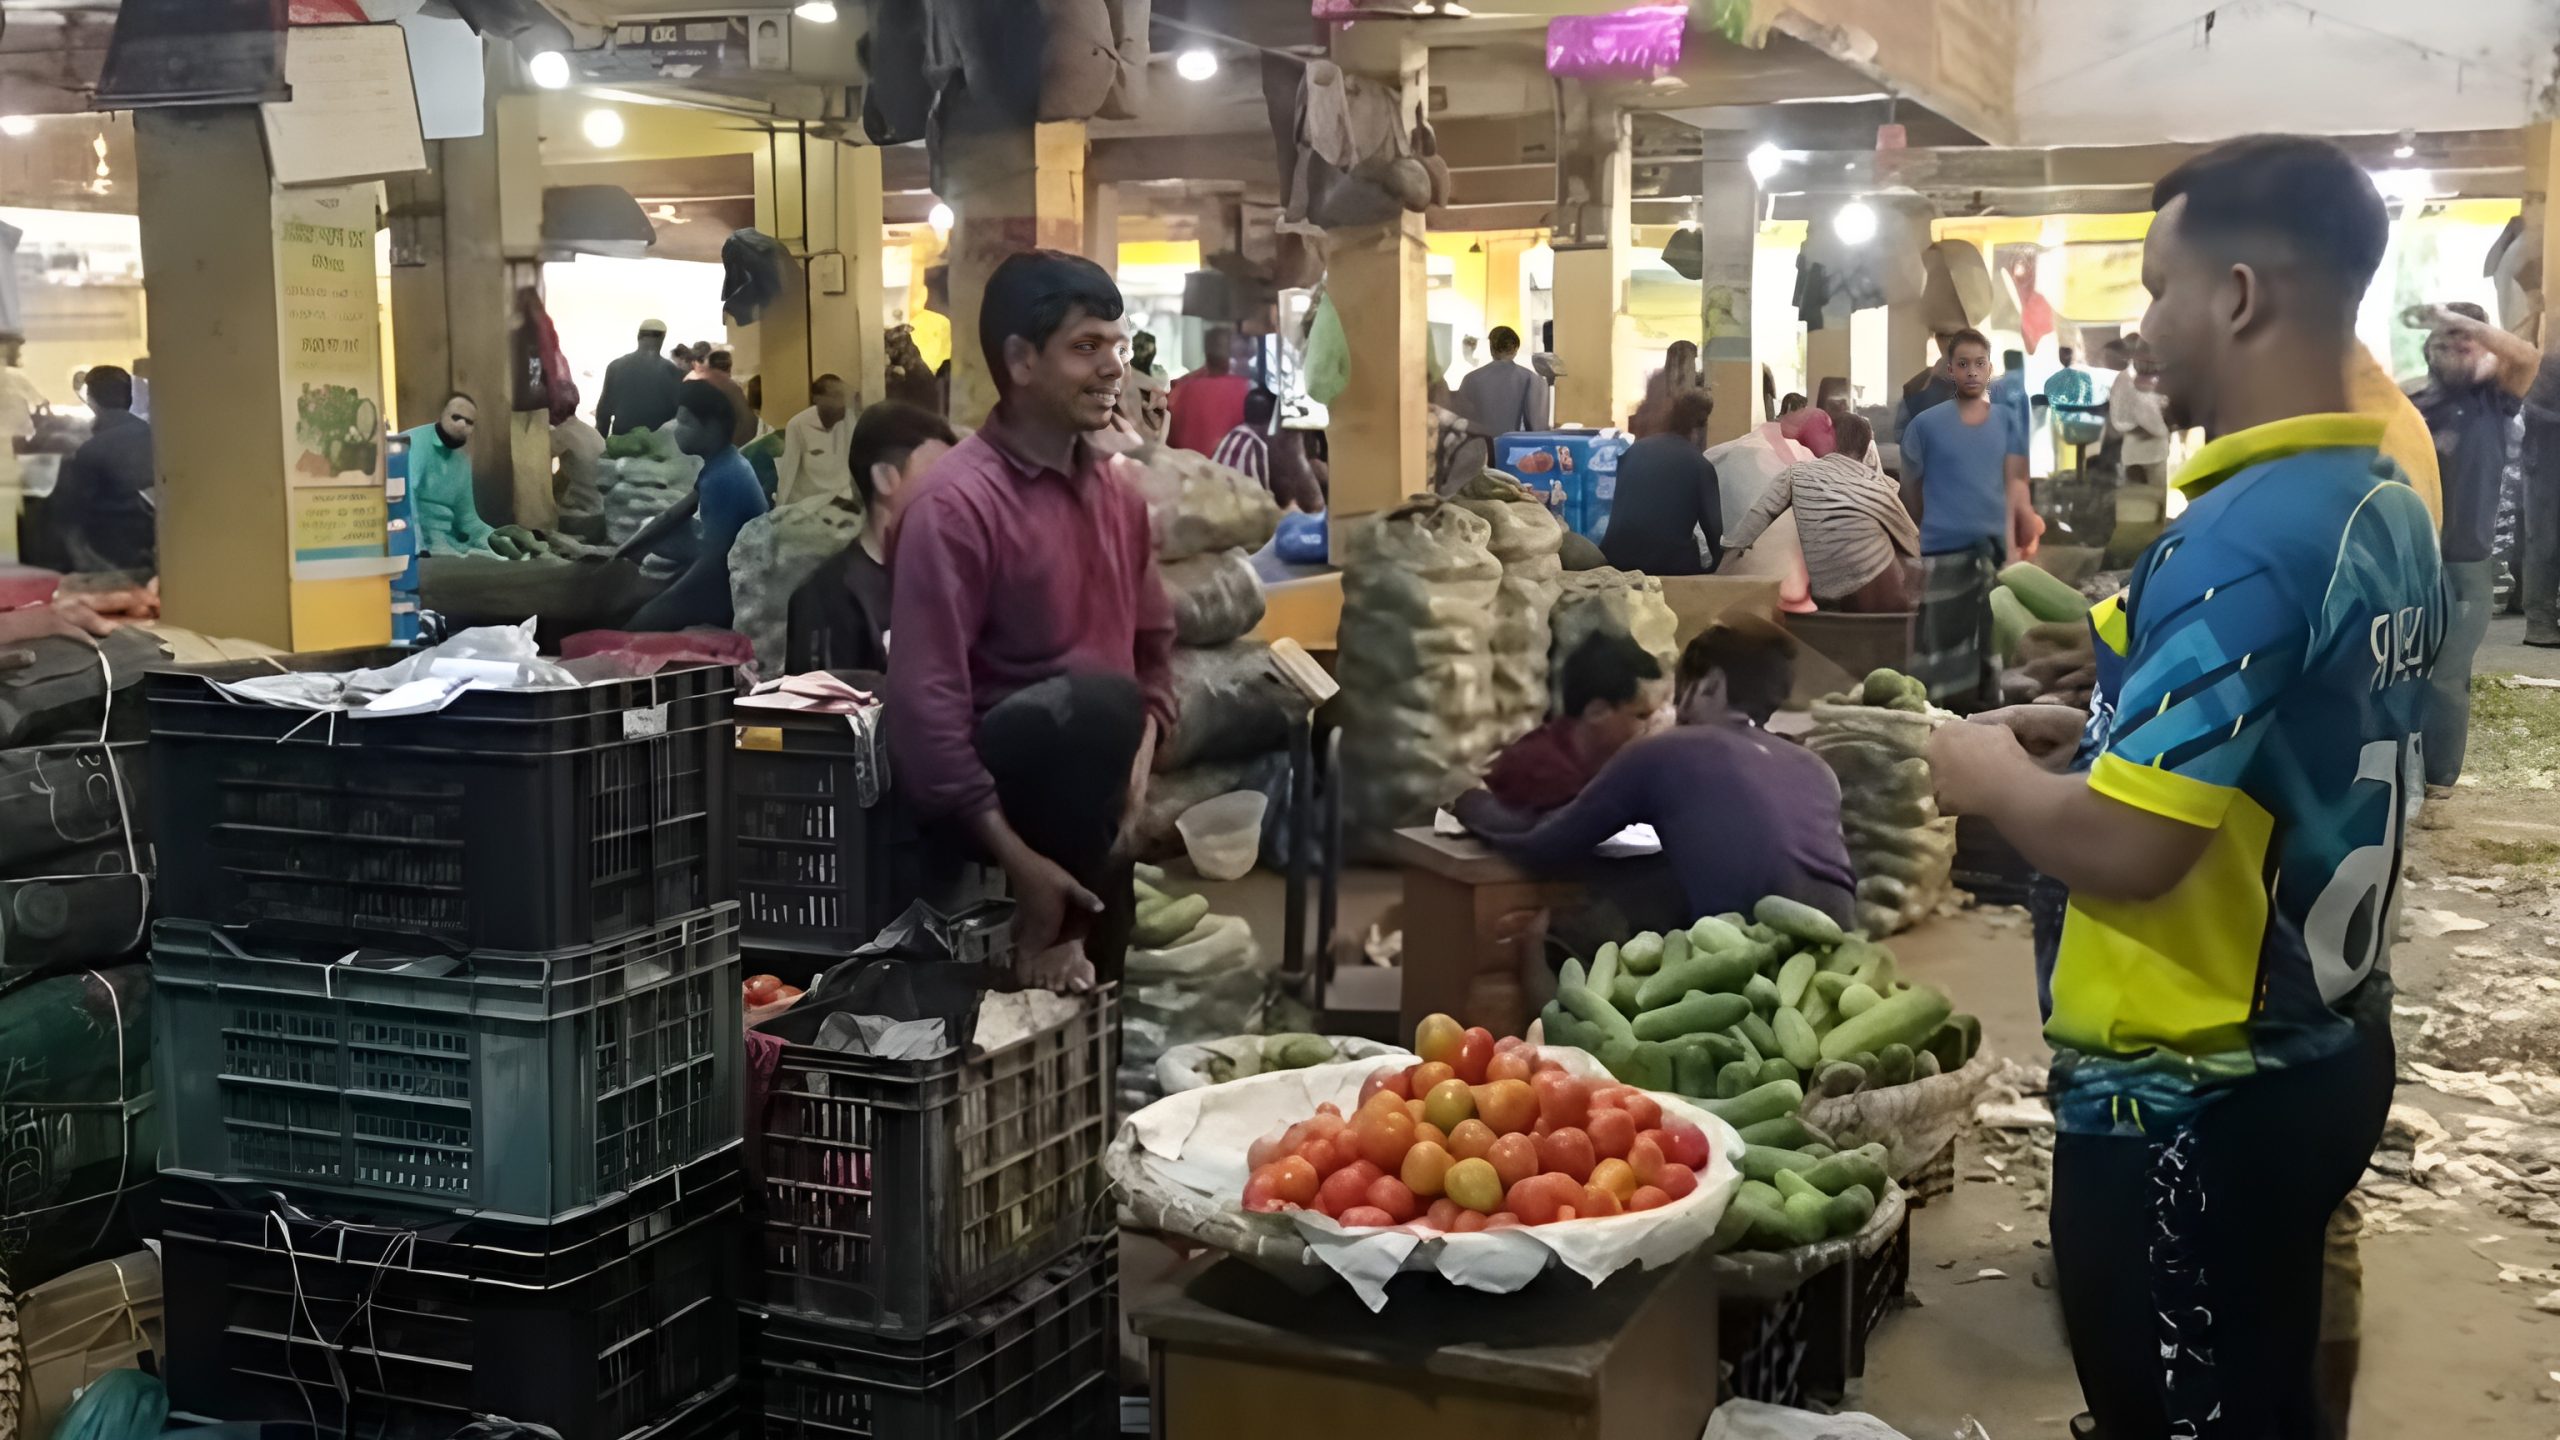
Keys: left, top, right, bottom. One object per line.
{"left": 755, "top": 1238, "right": 1119, "bottom": 1440}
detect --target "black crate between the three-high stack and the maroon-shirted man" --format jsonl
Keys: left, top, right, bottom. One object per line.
{"left": 732, "top": 707, "right": 924, "bottom": 953}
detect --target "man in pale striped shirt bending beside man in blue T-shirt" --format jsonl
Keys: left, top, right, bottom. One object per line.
{"left": 1725, "top": 415, "right": 1920, "bottom": 615}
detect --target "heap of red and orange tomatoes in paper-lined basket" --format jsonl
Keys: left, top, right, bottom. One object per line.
{"left": 1244, "top": 1015, "right": 1708, "bottom": 1219}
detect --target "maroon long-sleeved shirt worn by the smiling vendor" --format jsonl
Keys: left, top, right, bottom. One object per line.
{"left": 888, "top": 405, "right": 1175, "bottom": 820}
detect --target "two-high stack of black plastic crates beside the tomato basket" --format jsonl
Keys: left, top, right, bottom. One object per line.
{"left": 748, "top": 910, "right": 1119, "bottom": 1440}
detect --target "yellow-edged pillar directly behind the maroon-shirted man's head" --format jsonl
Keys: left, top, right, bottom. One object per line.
{"left": 942, "top": 120, "right": 1085, "bottom": 425}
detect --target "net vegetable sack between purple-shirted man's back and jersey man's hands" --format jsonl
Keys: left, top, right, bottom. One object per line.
{"left": 1805, "top": 705, "right": 1956, "bottom": 940}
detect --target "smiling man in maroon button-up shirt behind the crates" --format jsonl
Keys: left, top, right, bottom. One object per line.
{"left": 888, "top": 251, "right": 1175, "bottom": 989}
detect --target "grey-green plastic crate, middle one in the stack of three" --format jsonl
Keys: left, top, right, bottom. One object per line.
{"left": 151, "top": 904, "right": 745, "bottom": 1222}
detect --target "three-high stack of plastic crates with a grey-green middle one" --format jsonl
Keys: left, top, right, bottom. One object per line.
{"left": 148, "top": 653, "right": 745, "bottom": 1440}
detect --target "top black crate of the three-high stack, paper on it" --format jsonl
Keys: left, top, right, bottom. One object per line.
{"left": 148, "top": 651, "right": 732, "bottom": 951}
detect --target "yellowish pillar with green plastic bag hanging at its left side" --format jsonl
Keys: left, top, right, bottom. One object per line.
{"left": 1326, "top": 20, "right": 1431, "bottom": 564}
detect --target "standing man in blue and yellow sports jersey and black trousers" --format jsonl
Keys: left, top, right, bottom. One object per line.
{"left": 1930, "top": 138, "right": 2445, "bottom": 1440}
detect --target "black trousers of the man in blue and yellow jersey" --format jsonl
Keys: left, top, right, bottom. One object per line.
{"left": 2053, "top": 1025, "right": 2394, "bottom": 1440}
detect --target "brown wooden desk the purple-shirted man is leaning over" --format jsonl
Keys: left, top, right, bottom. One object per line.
{"left": 1388, "top": 828, "right": 1582, "bottom": 1038}
